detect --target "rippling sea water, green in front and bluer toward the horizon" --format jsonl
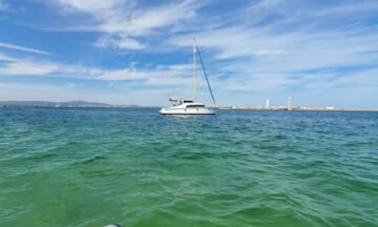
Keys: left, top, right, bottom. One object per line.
{"left": 0, "top": 108, "right": 378, "bottom": 227}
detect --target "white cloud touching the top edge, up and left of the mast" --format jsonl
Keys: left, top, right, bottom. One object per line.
{"left": 52, "top": 0, "right": 202, "bottom": 50}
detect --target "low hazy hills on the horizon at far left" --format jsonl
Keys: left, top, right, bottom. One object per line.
{"left": 0, "top": 101, "right": 131, "bottom": 107}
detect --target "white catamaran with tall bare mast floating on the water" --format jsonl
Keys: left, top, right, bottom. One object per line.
{"left": 159, "top": 39, "right": 215, "bottom": 115}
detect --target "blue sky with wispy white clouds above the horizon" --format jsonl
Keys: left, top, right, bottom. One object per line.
{"left": 0, "top": 0, "right": 378, "bottom": 108}
